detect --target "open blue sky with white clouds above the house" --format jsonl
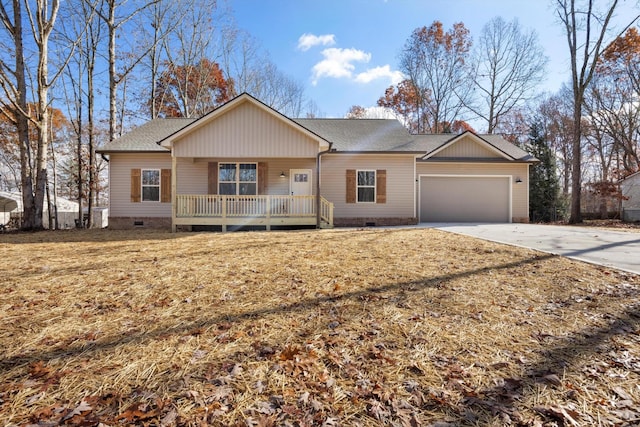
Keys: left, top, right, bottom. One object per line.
{"left": 229, "top": 0, "right": 570, "bottom": 117}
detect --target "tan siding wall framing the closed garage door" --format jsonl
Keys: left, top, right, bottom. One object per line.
{"left": 416, "top": 162, "right": 529, "bottom": 219}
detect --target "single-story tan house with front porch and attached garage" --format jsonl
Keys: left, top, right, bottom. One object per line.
{"left": 98, "top": 93, "right": 537, "bottom": 231}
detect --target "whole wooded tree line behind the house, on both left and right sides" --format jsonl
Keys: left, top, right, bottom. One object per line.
{"left": 0, "top": 0, "right": 640, "bottom": 229}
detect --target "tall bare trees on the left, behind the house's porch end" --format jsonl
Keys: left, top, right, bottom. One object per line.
{"left": 0, "top": 0, "right": 316, "bottom": 229}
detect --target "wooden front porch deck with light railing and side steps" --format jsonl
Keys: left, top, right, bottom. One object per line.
{"left": 173, "top": 194, "right": 333, "bottom": 231}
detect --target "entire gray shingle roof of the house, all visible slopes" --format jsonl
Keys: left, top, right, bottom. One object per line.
{"left": 98, "top": 118, "right": 535, "bottom": 161}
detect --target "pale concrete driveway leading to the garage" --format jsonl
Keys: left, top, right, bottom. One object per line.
{"left": 421, "top": 223, "right": 640, "bottom": 274}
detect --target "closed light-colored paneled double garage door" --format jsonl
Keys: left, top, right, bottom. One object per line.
{"left": 420, "top": 176, "right": 511, "bottom": 222}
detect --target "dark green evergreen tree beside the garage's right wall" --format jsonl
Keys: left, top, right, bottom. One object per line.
{"left": 528, "top": 120, "right": 567, "bottom": 222}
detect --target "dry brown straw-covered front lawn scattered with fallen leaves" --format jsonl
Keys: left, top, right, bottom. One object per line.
{"left": 0, "top": 229, "right": 640, "bottom": 426}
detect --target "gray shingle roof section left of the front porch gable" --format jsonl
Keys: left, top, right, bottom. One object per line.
{"left": 97, "top": 118, "right": 196, "bottom": 153}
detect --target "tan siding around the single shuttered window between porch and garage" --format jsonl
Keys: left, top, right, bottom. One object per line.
{"left": 321, "top": 154, "right": 415, "bottom": 218}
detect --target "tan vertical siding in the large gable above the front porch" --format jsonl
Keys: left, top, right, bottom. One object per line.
{"left": 174, "top": 103, "right": 319, "bottom": 158}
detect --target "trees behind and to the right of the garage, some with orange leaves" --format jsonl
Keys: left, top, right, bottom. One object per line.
{"left": 362, "top": 0, "right": 640, "bottom": 223}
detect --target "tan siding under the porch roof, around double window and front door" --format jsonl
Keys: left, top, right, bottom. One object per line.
{"left": 177, "top": 158, "right": 316, "bottom": 195}
